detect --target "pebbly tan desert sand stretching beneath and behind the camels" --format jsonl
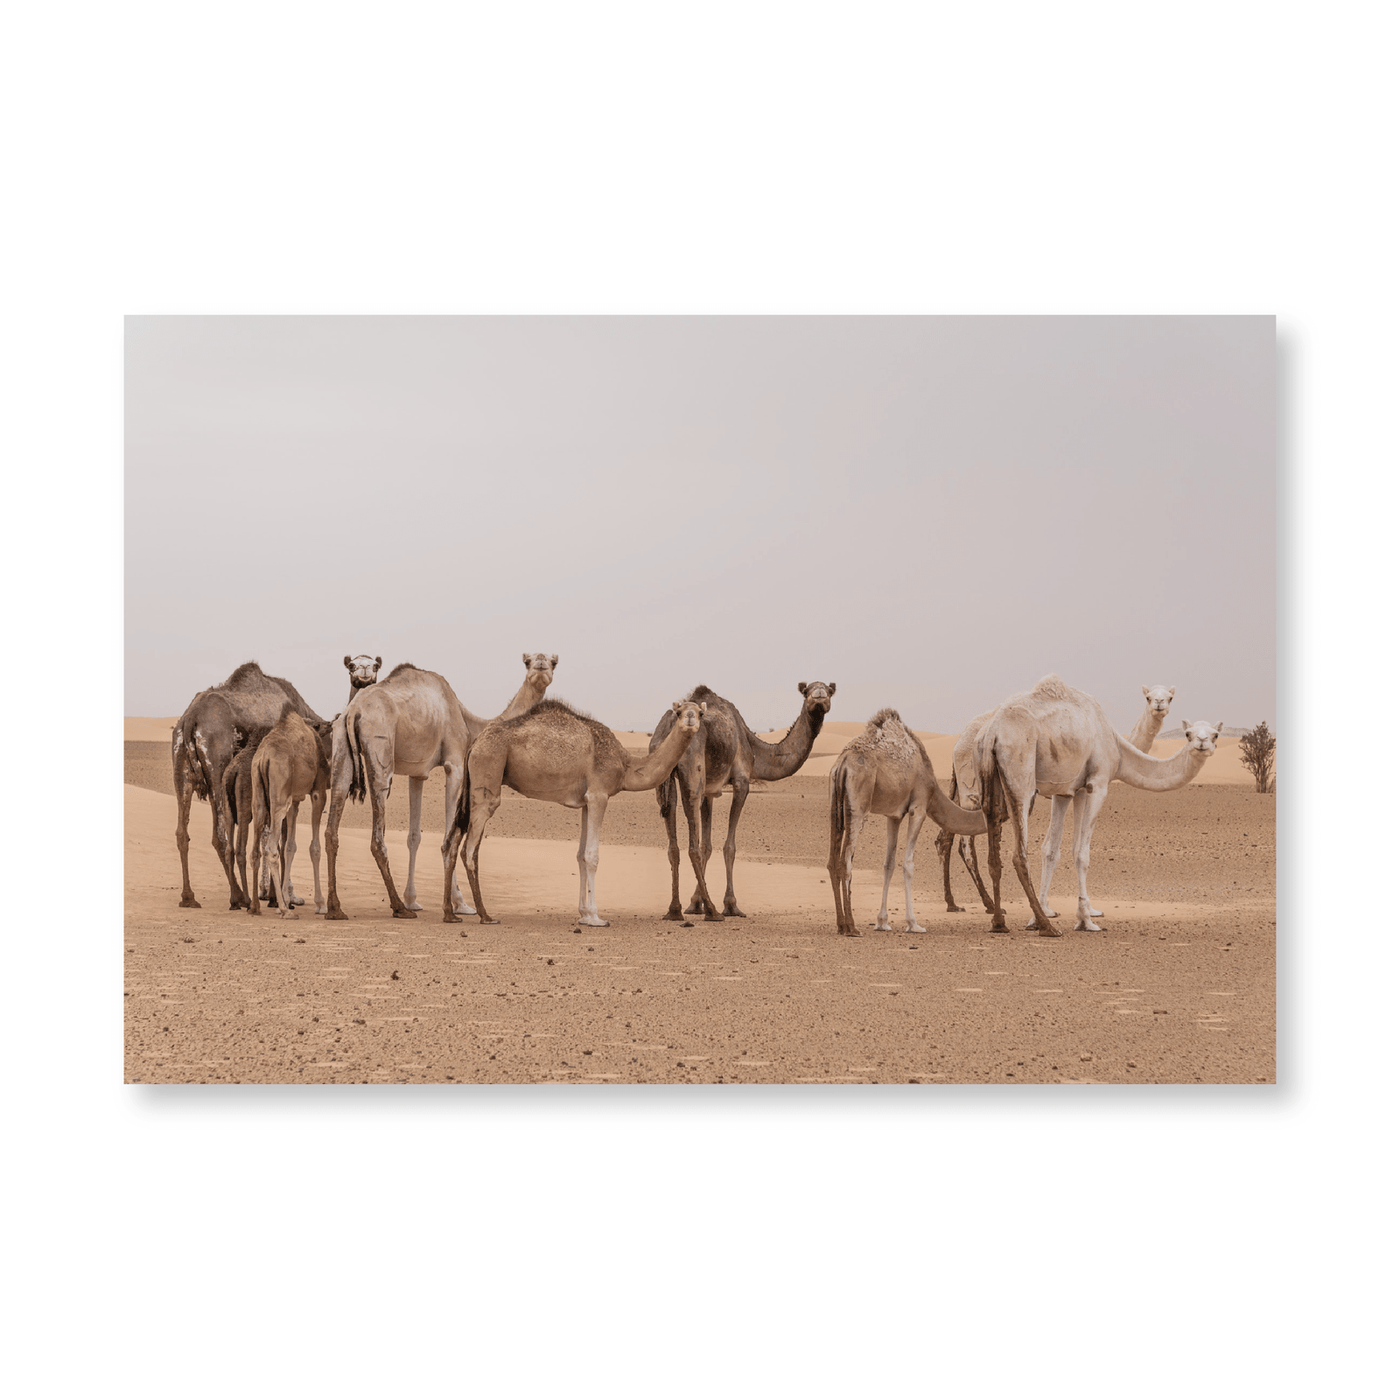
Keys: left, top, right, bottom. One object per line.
{"left": 126, "top": 735, "right": 1274, "bottom": 1084}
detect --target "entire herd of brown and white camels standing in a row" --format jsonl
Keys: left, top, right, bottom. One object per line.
{"left": 171, "top": 652, "right": 1222, "bottom": 935}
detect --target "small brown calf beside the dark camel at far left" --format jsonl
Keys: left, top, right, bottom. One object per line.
{"left": 248, "top": 704, "right": 330, "bottom": 918}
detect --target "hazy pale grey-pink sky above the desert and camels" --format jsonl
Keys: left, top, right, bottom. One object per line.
{"left": 126, "top": 316, "right": 1275, "bottom": 732}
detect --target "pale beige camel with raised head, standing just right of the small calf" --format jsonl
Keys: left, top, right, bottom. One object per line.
{"left": 326, "top": 651, "right": 559, "bottom": 918}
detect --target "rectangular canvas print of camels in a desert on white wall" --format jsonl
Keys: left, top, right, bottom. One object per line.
{"left": 123, "top": 316, "right": 1288, "bottom": 1086}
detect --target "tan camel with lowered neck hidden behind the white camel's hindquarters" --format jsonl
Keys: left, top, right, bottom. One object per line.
{"left": 826, "top": 710, "right": 987, "bottom": 938}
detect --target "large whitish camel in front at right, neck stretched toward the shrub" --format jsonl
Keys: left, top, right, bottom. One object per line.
{"left": 977, "top": 676, "right": 1224, "bottom": 938}
